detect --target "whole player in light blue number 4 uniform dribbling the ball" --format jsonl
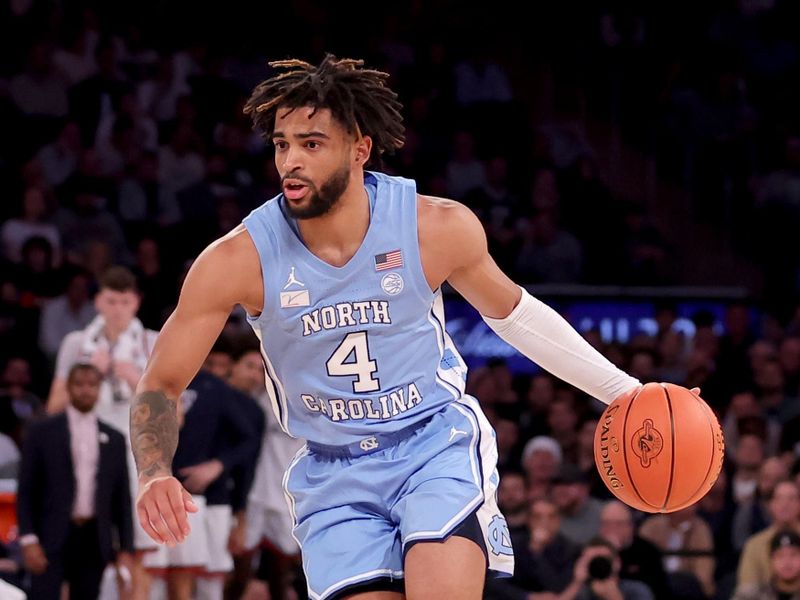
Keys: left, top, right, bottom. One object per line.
{"left": 131, "top": 55, "right": 639, "bottom": 600}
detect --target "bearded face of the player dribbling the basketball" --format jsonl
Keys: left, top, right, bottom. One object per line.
{"left": 272, "top": 107, "right": 368, "bottom": 219}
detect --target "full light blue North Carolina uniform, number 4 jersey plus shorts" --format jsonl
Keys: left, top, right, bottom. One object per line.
{"left": 244, "top": 173, "right": 514, "bottom": 600}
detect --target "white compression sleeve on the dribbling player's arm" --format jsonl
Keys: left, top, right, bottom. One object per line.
{"left": 483, "top": 288, "right": 640, "bottom": 404}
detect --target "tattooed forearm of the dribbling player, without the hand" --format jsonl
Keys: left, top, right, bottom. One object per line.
{"left": 131, "top": 391, "right": 178, "bottom": 481}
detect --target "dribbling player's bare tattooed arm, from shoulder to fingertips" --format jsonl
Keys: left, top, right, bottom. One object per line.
{"left": 130, "top": 226, "right": 264, "bottom": 545}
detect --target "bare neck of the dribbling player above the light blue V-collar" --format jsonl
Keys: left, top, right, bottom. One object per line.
{"left": 297, "top": 179, "right": 370, "bottom": 266}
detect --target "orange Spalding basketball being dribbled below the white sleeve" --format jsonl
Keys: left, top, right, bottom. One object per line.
{"left": 594, "top": 383, "right": 725, "bottom": 513}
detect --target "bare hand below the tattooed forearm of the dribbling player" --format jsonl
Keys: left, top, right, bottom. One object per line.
{"left": 136, "top": 475, "right": 198, "bottom": 547}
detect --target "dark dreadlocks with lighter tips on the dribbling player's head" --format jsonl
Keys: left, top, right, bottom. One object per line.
{"left": 244, "top": 54, "right": 405, "bottom": 157}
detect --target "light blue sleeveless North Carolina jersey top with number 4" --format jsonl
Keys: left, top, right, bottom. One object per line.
{"left": 244, "top": 172, "right": 467, "bottom": 446}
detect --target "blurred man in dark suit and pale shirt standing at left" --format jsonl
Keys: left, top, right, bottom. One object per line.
{"left": 17, "top": 364, "right": 133, "bottom": 600}
